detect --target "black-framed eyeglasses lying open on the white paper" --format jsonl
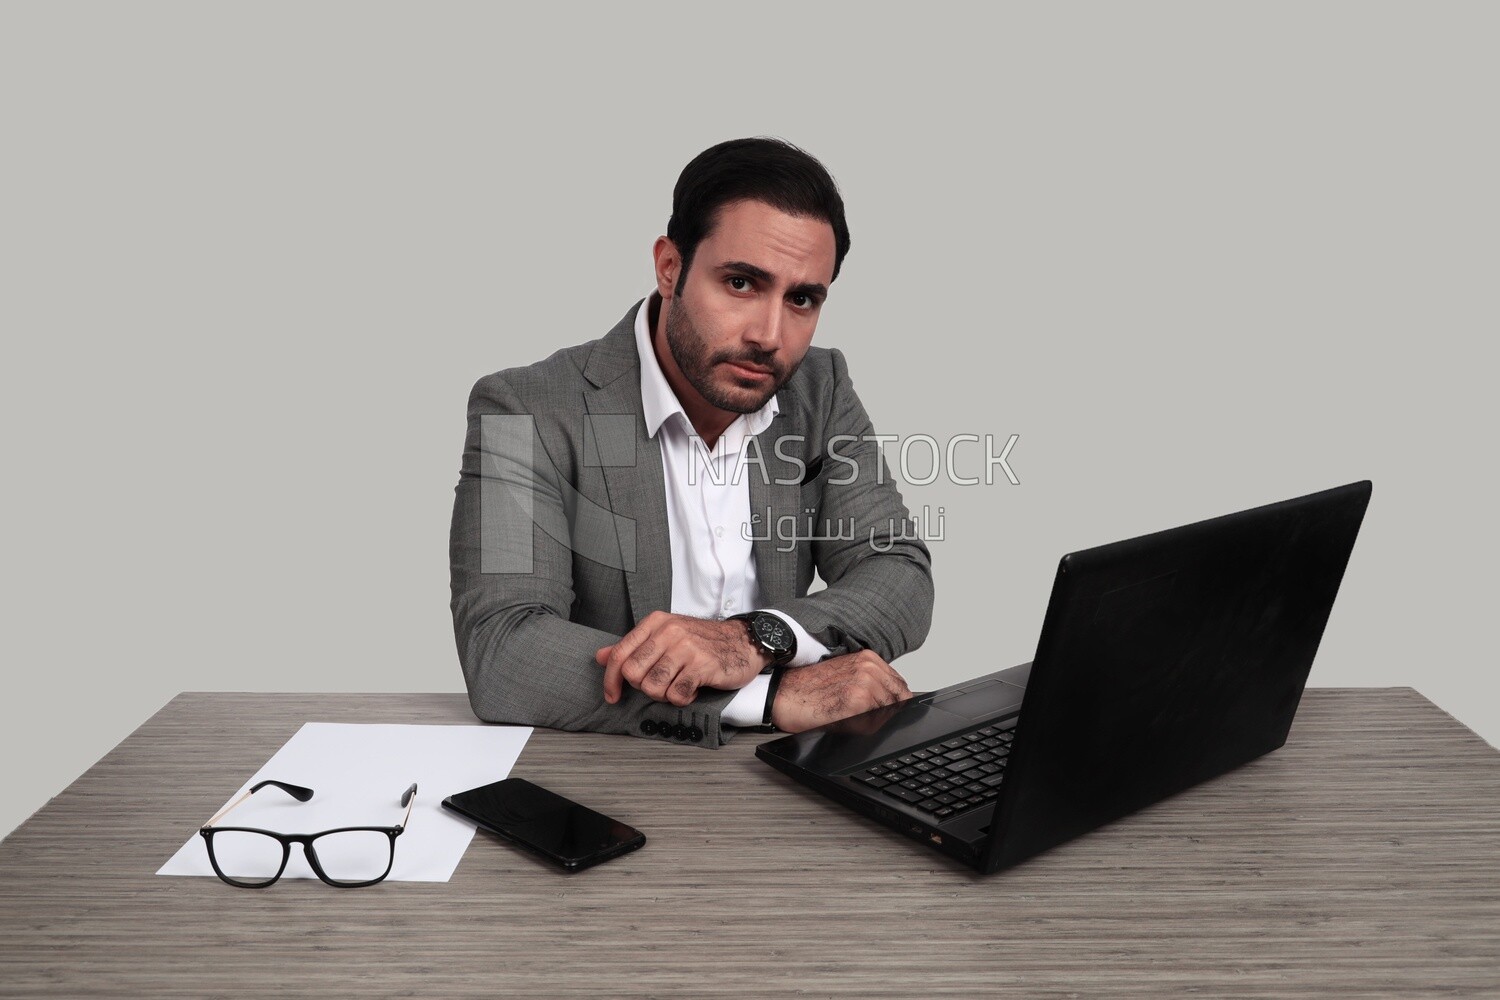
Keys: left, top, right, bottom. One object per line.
{"left": 198, "top": 781, "right": 417, "bottom": 889}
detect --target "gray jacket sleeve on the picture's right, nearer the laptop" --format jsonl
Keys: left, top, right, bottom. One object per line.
{"left": 773, "top": 351, "right": 933, "bottom": 663}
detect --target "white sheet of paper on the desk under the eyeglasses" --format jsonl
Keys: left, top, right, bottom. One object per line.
{"left": 156, "top": 723, "right": 531, "bottom": 882}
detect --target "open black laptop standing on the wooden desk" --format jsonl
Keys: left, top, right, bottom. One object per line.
{"left": 756, "top": 481, "right": 1371, "bottom": 874}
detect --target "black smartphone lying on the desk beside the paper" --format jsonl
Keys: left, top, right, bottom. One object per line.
{"left": 443, "top": 778, "right": 647, "bottom": 871}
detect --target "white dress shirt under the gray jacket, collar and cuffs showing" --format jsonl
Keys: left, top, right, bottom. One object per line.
{"left": 636, "top": 292, "right": 828, "bottom": 726}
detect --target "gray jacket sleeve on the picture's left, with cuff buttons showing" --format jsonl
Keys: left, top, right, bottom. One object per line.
{"left": 449, "top": 373, "right": 734, "bottom": 747}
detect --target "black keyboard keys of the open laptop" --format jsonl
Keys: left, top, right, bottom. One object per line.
{"left": 849, "top": 718, "right": 1016, "bottom": 823}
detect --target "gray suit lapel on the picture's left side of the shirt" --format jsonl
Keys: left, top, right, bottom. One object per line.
{"left": 584, "top": 306, "right": 672, "bottom": 622}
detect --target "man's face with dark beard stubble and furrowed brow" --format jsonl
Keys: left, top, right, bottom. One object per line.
{"left": 659, "top": 201, "right": 836, "bottom": 415}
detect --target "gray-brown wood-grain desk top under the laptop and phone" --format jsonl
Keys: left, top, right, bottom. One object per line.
{"left": 0, "top": 688, "right": 1500, "bottom": 997}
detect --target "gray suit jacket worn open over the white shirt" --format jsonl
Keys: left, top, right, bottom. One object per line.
{"left": 450, "top": 303, "right": 933, "bottom": 747}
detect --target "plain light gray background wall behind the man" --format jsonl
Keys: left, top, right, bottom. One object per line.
{"left": 0, "top": 3, "right": 1500, "bottom": 831}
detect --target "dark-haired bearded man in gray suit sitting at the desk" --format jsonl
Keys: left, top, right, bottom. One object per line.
{"left": 450, "top": 138, "right": 933, "bottom": 747}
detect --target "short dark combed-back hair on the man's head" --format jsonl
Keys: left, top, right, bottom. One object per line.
{"left": 666, "top": 136, "right": 849, "bottom": 292}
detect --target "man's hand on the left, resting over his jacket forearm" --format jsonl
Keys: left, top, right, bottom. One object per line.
{"left": 594, "top": 612, "right": 771, "bottom": 706}
